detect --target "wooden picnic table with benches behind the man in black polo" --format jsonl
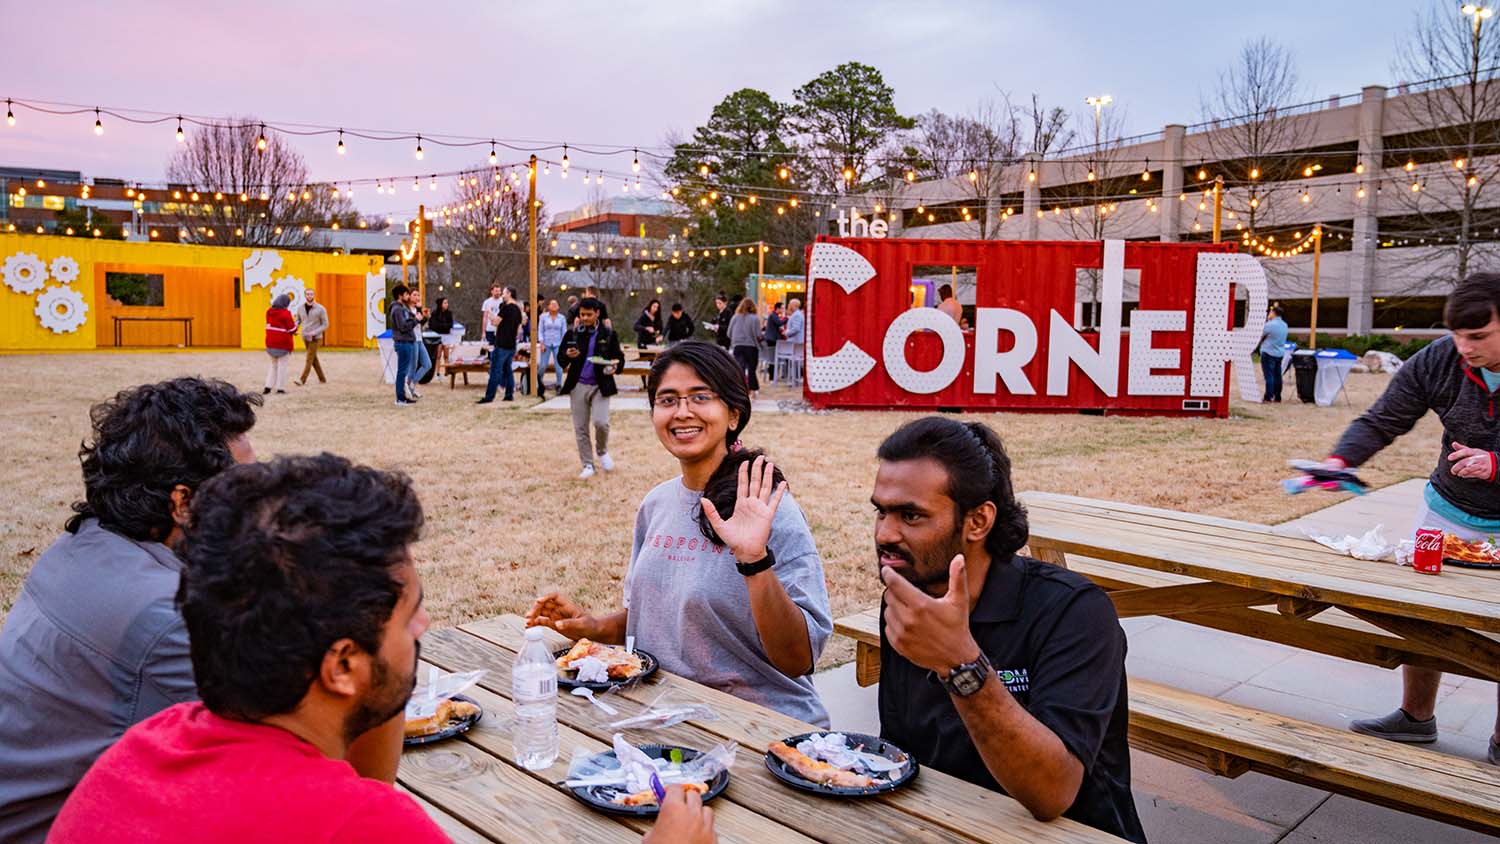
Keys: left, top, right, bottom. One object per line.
{"left": 834, "top": 492, "right": 1500, "bottom": 834}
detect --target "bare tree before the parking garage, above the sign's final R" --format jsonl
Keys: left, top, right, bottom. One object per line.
{"left": 1202, "top": 36, "right": 1313, "bottom": 231}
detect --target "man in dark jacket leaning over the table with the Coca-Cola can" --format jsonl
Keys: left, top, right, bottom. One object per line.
{"left": 1325, "top": 273, "right": 1500, "bottom": 765}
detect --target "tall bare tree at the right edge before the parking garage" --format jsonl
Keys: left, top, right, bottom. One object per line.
{"left": 1388, "top": 3, "right": 1500, "bottom": 286}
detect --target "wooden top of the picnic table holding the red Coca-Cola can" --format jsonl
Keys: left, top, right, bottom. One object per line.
{"left": 1020, "top": 492, "right": 1500, "bottom": 633}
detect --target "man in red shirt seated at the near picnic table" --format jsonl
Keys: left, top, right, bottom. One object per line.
{"left": 48, "top": 454, "right": 714, "bottom": 844}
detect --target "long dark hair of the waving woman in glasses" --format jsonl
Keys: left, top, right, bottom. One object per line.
{"left": 647, "top": 340, "right": 786, "bottom": 544}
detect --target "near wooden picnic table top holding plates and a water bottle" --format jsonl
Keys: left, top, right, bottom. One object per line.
{"left": 398, "top": 615, "right": 1118, "bottom": 844}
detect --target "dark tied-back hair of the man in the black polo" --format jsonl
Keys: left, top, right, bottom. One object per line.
{"left": 876, "top": 417, "right": 1029, "bottom": 559}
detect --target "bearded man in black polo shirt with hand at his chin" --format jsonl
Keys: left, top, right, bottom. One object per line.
{"left": 870, "top": 417, "right": 1146, "bottom": 843}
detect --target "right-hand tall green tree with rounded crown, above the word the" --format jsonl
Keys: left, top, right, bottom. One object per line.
{"left": 792, "top": 61, "right": 915, "bottom": 190}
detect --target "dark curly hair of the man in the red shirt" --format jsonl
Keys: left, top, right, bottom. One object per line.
{"left": 177, "top": 454, "right": 423, "bottom": 721}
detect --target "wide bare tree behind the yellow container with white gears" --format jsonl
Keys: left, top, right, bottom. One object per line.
{"left": 167, "top": 117, "right": 345, "bottom": 249}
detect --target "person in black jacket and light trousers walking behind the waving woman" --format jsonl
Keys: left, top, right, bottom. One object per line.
{"left": 558, "top": 297, "right": 626, "bottom": 480}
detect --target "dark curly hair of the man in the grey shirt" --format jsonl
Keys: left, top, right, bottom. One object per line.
{"left": 66, "top": 378, "right": 261, "bottom": 543}
